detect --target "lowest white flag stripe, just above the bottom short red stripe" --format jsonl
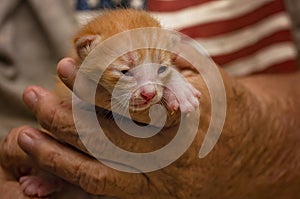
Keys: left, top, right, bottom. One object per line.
{"left": 223, "top": 42, "right": 297, "bottom": 76}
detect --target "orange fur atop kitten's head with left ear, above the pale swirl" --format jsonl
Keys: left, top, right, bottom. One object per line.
{"left": 73, "top": 9, "right": 161, "bottom": 62}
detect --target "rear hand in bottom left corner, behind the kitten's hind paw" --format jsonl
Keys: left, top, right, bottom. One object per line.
{"left": 0, "top": 126, "right": 97, "bottom": 199}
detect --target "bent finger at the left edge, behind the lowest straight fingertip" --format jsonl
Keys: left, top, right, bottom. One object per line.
{"left": 0, "top": 126, "right": 32, "bottom": 178}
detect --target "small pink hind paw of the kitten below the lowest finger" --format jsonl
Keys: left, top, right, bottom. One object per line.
{"left": 19, "top": 175, "right": 62, "bottom": 197}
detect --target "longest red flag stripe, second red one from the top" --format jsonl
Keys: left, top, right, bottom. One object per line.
{"left": 180, "top": 0, "right": 284, "bottom": 38}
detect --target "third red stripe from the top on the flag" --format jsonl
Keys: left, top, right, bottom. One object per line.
{"left": 212, "top": 30, "right": 294, "bottom": 65}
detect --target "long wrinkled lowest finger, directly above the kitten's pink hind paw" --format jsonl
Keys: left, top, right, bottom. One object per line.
{"left": 18, "top": 131, "right": 147, "bottom": 198}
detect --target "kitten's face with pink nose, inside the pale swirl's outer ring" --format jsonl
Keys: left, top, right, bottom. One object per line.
{"left": 99, "top": 49, "right": 172, "bottom": 111}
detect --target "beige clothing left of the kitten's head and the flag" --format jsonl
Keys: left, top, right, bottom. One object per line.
{"left": 0, "top": 0, "right": 77, "bottom": 135}
